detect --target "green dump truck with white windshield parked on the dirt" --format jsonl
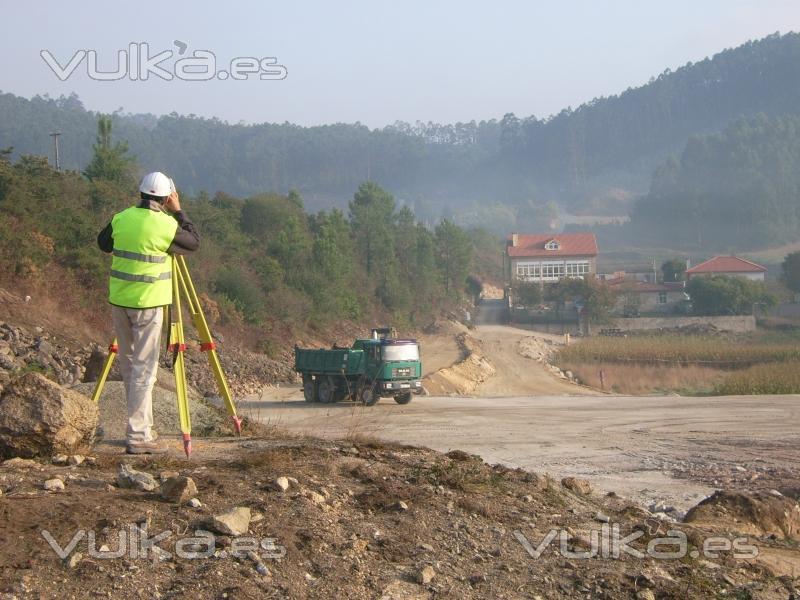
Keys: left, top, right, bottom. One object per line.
{"left": 294, "top": 328, "right": 422, "bottom": 406}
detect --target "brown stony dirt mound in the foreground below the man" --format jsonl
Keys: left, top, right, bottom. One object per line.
{"left": 0, "top": 435, "right": 798, "bottom": 600}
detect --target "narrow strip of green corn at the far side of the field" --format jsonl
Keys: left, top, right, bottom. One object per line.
{"left": 557, "top": 335, "right": 800, "bottom": 369}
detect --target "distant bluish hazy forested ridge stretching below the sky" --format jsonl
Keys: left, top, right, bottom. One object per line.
{"left": 0, "top": 33, "right": 800, "bottom": 219}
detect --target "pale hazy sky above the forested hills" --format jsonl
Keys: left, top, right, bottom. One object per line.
{"left": 6, "top": 0, "right": 800, "bottom": 126}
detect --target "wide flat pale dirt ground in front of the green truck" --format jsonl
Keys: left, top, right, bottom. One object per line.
{"left": 243, "top": 396, "right": 800, "bottom": 510}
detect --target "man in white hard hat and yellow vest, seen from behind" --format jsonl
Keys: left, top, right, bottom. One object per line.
{"left": 97, "top": 172, "right": 200, "bottom": 454}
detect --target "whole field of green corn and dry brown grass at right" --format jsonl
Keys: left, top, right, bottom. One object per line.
{"left": 555, "top": 333, "right": 800, "bottom": 395}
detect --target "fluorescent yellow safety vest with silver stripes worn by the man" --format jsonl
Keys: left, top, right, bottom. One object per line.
{"left": 108, "top": 206, "right": 178, "bottom": 309}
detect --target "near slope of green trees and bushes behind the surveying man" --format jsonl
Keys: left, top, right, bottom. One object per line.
{"left": 0, "top": 119, "right": 499, "bottom": 351}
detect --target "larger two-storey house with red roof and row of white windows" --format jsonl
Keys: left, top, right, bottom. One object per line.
{"left": 505, "top": 233, "right": 599, "bottom": 282}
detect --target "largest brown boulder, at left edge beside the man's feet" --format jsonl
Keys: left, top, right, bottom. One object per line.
{"left": 0, "top": 373, "right": 98, "bottom": 457}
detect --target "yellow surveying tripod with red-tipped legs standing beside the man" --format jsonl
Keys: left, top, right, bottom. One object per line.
{"left": 92, "top": 254, "right": 242, "bottom": 457}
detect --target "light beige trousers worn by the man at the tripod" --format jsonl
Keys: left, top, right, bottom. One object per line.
{"left": 111, "top": 306, "right": 164, "bottom": 442}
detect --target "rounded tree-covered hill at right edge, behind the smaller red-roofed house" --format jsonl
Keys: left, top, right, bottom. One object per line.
{"left": 628, "top": 115, "right": 800, "bottom": 250}
